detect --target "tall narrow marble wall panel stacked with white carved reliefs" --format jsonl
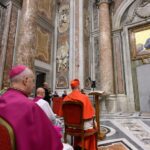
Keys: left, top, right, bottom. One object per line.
{"left": 56, "top": 0, "right": 70, "bottom": 89}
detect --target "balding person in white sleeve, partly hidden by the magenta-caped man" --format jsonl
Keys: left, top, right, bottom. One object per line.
{"left": 33, "top": 87, "right": 62, "bottom": 127}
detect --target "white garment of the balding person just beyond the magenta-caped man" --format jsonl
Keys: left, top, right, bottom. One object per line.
{"left": 36, "top": 99, "right": 62, "bottom": 127}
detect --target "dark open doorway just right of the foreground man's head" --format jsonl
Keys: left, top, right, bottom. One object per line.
{"left": 36, "top": 71, "right": 46, "bottom": 89}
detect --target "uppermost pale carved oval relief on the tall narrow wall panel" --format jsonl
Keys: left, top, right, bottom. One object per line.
{"left": 58, "top": 5, "right": 69, "bottom": 33}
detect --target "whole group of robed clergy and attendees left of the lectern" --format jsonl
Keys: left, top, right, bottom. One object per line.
{"left": 0, "top": 65, "right": 96, "bottom": 150}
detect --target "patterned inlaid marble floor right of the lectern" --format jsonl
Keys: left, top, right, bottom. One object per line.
{"left": 59, "top": 112, "right": 150, "bottom": 150}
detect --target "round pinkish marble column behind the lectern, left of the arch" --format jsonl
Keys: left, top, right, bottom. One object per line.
{"left": 97, "top": 0, "right": 114, "bottom": 94}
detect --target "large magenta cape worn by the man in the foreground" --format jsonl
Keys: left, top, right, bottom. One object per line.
{"left": 0, "top": 89, "right": 63, "bottom": 150}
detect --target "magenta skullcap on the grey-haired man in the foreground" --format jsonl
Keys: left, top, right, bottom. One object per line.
{"left": 9, "top": 65, "right": 27, "bottom": 79}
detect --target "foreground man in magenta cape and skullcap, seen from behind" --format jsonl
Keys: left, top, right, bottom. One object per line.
{"left": 0, "top": 65, "right": 63, "bottom": 150}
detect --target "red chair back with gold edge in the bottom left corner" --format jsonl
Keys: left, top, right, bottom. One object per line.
{"left": 0, "top": 117, "right": 15, "bottom": 150}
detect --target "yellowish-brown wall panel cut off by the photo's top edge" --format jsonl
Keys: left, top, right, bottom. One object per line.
{"left": 38, "top": 0, "right": 55, "bottom": 20}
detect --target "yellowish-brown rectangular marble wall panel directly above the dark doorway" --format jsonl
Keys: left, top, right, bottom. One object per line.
{"left": 36, "top": 26, "right": 52, "bottom": 63}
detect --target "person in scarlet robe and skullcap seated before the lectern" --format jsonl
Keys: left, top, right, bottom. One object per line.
{"left": 64, "top": 79, "right": 96, "bottom": 150}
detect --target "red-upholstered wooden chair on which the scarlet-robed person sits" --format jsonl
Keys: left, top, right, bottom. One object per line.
{"left": 62, "top": 101, "right": 97, "bottom": 149}
